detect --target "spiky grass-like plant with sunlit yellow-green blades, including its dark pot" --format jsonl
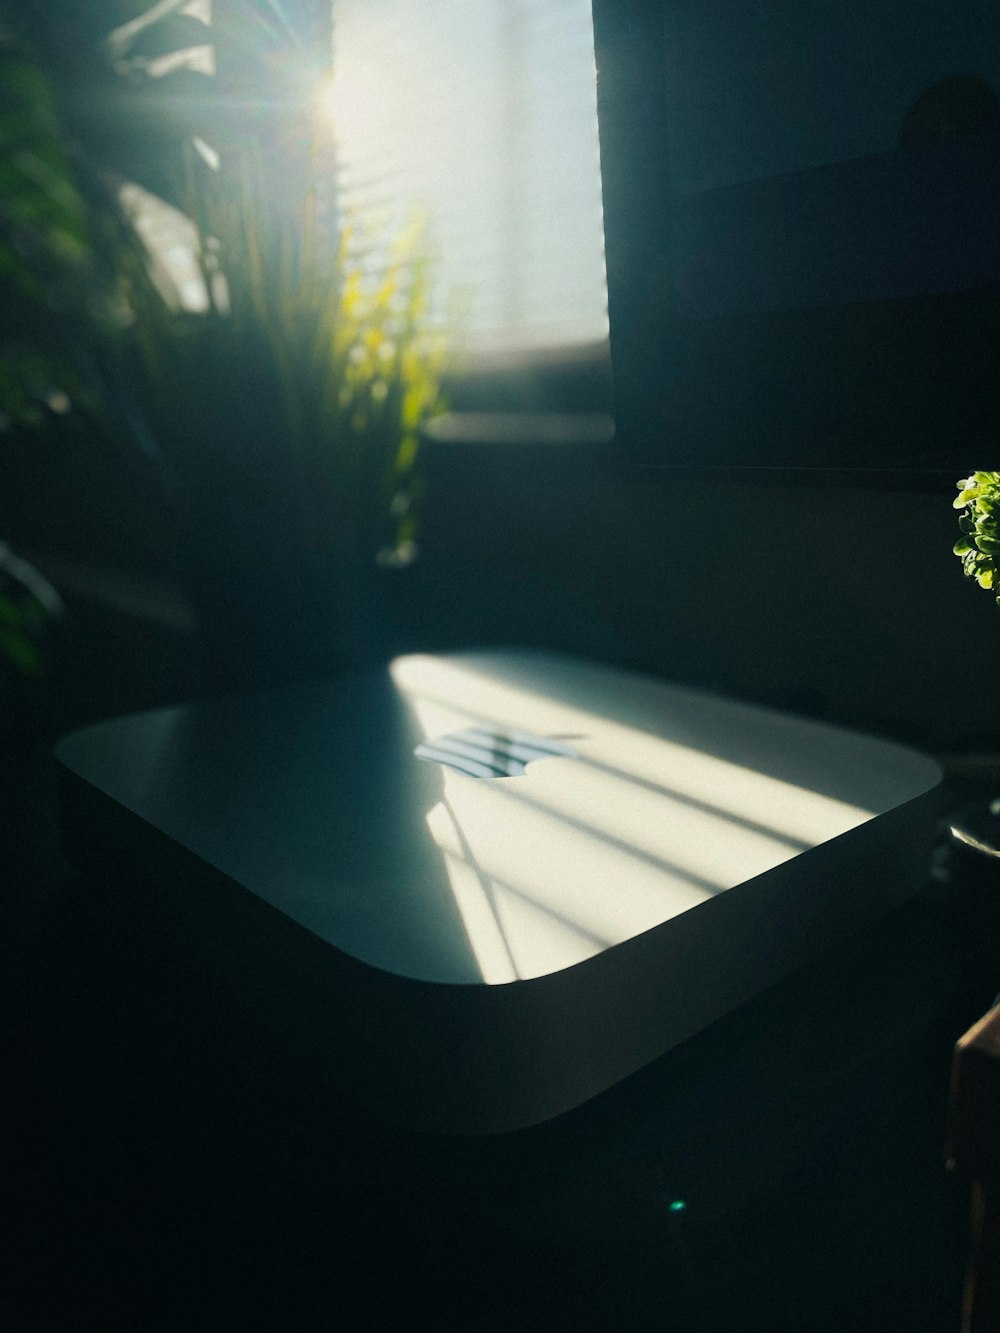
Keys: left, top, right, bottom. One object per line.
{"left": 130, "top": 155, "right": 444, "bottom": 682}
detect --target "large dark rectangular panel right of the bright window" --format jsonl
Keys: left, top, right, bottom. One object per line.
{"left": 593, "top": 0, "right": 1000, "bottom": 469}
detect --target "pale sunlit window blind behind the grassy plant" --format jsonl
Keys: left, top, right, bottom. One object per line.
{"left": 331, "top": 0, "right": 607, "bottom": 353}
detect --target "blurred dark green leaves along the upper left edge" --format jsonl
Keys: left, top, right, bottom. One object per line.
{"left": 0, "top": 0, "right": 197, "bottom": 435}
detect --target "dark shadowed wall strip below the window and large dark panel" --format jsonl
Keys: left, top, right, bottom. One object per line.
{"left": 412, "top": 445, "right": 1000, "bottom": 750}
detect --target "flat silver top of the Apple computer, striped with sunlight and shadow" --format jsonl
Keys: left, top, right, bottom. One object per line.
{"left": 57, "top": 652, "right": 940, "bottom": 985}
